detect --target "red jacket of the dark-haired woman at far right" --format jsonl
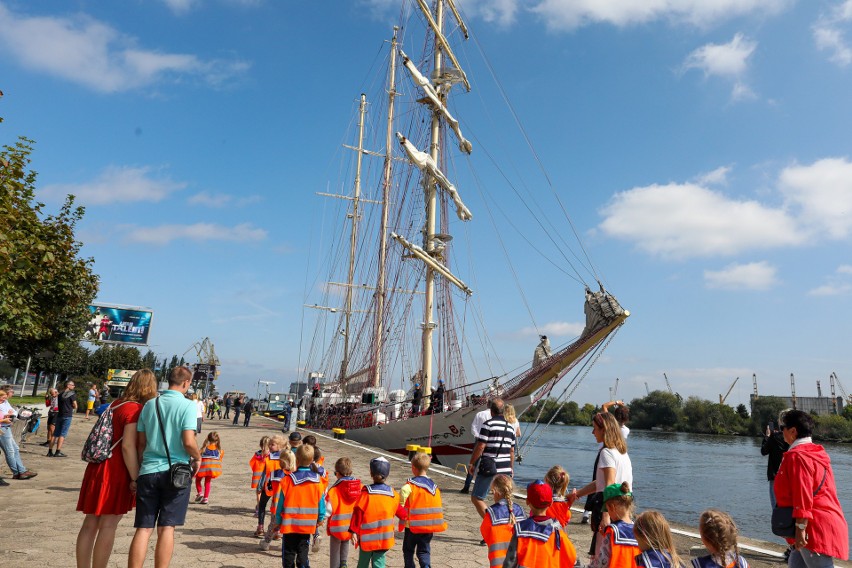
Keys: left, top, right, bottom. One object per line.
{"left": 774, "top": 443, "right": 849, "bottom": 560}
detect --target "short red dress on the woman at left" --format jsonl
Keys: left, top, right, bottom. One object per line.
{"left": 77, "top": 400, "right": 142, "bottom": 515}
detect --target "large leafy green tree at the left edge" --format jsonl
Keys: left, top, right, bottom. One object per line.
{"left": 0, "top": 137, "right": 98, "bottom": 382}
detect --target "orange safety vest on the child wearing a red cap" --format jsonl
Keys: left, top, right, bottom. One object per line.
{"left": 515, "top": 518, "right": 580, "bottom": 568}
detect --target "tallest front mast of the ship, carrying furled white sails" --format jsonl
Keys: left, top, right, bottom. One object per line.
{"left": 422, "top": 0, "right": 446, "bottom": 402}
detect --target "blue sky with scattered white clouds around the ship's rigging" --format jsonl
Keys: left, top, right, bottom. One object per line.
{"left": 0, "top": 0, "right": 852, "bottom": 404}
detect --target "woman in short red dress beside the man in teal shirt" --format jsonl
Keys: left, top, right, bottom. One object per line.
{"left": 77, "top": 369, "right": 157, "bottom": 568}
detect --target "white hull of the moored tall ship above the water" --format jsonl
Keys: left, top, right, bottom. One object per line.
{"left": 336, "top": 396, "right": 532, "bottom": 469}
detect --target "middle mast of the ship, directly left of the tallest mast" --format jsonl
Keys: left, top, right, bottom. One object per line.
{"left": 373, "top": 26, "right": 399, "bottom": 387}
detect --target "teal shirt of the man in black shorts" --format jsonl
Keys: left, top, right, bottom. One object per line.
{"left": 136, "top": 390, "right": 198, "bottom": 475}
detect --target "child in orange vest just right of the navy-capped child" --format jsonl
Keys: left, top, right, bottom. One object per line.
{"left": 399, "top": 452, "right": 447, "bottom": 568}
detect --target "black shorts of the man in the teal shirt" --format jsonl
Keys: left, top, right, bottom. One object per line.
{"left": 133, "top": 471, "right": 190, "bottom": 529}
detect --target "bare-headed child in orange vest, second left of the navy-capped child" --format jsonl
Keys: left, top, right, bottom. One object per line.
{"left": 264, "top": 445, "right": 325, "bottom": 568}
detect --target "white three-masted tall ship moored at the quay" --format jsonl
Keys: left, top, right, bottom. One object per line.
{"left": 300, "top": 0, "right": 629, "bottom": 467}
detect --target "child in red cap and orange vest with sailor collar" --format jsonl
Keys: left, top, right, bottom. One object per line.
{"left": 503, "top": 481, "right": 577, "bottom": 568}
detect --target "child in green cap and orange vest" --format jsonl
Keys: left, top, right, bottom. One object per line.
{"left": 589, "top": 481, "right": 641, "bottom": 568}
